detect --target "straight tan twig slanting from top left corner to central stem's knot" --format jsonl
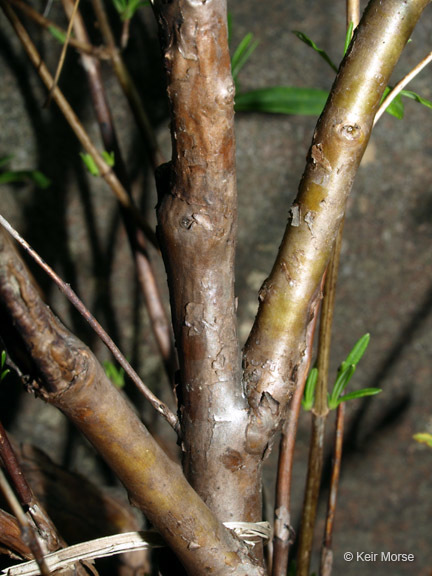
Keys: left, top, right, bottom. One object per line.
{"left": 0, "top": 0, "right": 157, "bottom": 246}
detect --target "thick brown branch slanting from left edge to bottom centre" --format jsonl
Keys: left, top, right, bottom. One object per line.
{"left": 0, "top": 231, "right": 264, "bottom": 576}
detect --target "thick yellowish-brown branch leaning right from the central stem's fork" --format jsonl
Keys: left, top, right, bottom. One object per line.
{"left": 244, "top": 0, "right": 428, "bottom": 450}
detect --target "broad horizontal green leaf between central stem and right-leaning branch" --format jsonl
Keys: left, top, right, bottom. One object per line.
{"left": 235, "top": 86, "right": 328, "bottom": 116}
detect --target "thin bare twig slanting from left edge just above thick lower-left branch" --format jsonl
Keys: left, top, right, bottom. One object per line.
{"left": 0, "top": 215, "right": 179, "bottom": 433}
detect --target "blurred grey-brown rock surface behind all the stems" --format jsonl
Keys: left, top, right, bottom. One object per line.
{"left": 0, "top": 0, "right": 432, "bottom": 576}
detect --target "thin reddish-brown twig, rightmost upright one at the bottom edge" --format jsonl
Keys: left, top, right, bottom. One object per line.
{"left": 320, "top": 402, "right": 345, "bottom": 576}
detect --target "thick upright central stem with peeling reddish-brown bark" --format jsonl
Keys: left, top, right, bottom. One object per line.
{"left": 154, "top": 0, "right": 261, "bottom": 521}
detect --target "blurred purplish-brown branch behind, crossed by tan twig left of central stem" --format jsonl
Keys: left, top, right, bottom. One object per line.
{"left": 63, "top": 0, "right": 177, "bottom": 386}
